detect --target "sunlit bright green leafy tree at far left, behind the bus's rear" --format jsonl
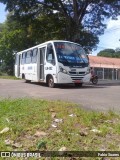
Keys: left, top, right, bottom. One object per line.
{"left": 0, "top": 15, "right": 34, "bottom": 74}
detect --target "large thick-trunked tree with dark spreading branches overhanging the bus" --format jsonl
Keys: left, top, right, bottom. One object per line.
{"left": 0, "top": 0, "right": 120, "bottom": 48}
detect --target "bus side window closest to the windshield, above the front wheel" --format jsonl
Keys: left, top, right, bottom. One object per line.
{"left": 46, "top": 44, "right": 55, "bottom": 64}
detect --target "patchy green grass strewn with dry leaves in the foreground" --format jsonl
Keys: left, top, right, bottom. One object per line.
{"left": 0, "top": 99, "right": 120, "bottom": 160}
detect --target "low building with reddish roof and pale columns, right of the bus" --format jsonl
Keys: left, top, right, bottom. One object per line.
{"left": 89, "top": 55, "right": 120, "bottom": 80}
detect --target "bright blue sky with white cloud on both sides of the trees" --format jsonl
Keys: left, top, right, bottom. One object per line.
{"left": 0, "top": 3, "right": 120, "bottom": 56}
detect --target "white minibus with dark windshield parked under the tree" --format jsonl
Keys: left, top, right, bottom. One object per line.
{"left": 15, "top": 40, "right": 91, "bottom": 88}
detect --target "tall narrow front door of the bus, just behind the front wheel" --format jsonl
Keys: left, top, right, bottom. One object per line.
{"left": 37, "top": 47, "right": 46, "bottom": 80}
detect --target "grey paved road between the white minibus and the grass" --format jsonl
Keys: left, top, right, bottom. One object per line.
{"left": 0, "top": 79, "right": 120, "bottom": 112}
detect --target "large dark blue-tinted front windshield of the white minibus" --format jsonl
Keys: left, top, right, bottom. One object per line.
{"left": 54, "top": 42, "right": 88, "bottom": 67}
